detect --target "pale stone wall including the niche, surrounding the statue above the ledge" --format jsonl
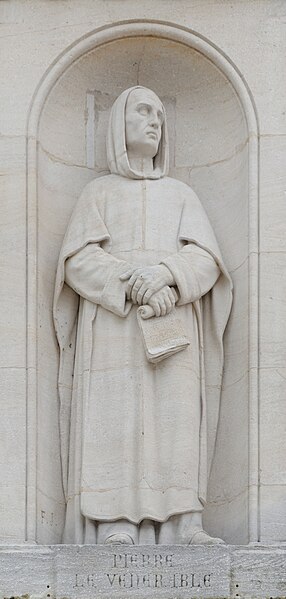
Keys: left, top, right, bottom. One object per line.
{"left": 0, "top": 0, "right": 286, "bottom": 544}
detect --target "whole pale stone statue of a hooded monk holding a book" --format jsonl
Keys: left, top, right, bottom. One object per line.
{"left": 54, "top": 86, "right": 232, "bottom": 544}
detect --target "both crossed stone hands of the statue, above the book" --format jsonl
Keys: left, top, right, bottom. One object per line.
{"left": 120, "top": 264, "right": 178, "bottom": 316}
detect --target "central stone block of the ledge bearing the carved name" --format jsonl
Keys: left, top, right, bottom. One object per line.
{"left": 56, "top": 545, "right": 230, "bottom": 599}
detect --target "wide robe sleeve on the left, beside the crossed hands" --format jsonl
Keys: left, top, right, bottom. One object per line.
{"left": 65, "top": 243, "right": 132, "bottom": 317}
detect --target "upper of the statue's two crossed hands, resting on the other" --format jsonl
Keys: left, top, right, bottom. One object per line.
{"left": 120, "top": 264, "right": 174, "bottom": 306}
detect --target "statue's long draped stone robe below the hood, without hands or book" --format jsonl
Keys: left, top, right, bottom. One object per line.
{"left": 54, "top": 174, "right": 232, "bottom": 542}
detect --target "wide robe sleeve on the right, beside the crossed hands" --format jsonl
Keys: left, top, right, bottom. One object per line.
{"left": 161, "top": 243, "right": 220, "bottom": 305}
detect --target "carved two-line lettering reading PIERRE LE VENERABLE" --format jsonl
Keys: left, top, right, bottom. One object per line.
{"left": 73, "top": 553, "right": 213, "bottom": 591}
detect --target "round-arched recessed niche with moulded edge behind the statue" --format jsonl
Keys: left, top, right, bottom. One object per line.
{"left": 27, "top": 23, "right": 258, "bottom": 543}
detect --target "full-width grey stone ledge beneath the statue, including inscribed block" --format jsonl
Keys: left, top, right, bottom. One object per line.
{"left": 0, "top": 544, "right": 286, "bottom": 599}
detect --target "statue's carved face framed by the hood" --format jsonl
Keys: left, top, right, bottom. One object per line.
{"left": 125, "top": 89, "right": 164, "bottom": 158}
